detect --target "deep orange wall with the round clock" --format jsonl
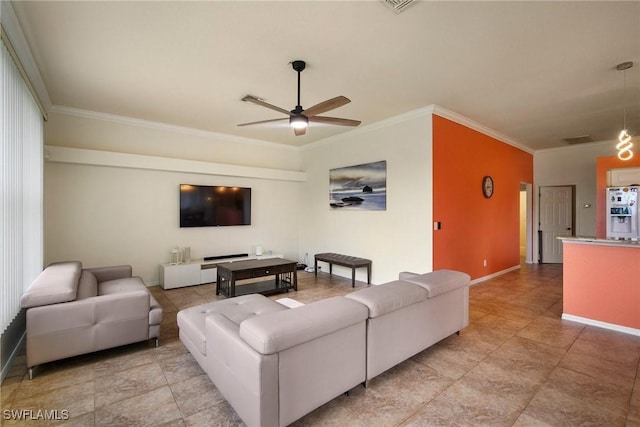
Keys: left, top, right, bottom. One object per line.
{"left": 433, "top": 115, "right": 533, "bottom": 279}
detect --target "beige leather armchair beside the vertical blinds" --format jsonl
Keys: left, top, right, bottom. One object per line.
{"left": 21, "top": 261, "right": 162, "bottom": 376}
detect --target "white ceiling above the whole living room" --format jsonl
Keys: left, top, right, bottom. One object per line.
{"left": 14, "top": 1, "right": 640, "bottom": 150}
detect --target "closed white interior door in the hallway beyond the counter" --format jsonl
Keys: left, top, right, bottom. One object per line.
{"left": 539, "top": 186, "right": 573, "bottom": 263}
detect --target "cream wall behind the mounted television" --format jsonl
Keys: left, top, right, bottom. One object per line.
{"left": 44, "top": 110, "right": 304, "bottom": 284}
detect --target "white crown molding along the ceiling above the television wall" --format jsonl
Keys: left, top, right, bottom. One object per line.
{"left": 50, "top": 105, "right": 298, "bottom": 151}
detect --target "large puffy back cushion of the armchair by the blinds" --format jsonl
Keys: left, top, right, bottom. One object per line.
{"left": 20, "top": 261, "right": 82, "bottom": 308}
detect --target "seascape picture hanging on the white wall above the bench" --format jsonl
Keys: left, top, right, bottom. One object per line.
{"left": 329, "top": 160, "right": 387, "bottom": 211}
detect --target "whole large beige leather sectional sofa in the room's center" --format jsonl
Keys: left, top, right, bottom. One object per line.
{"left": 177, "top": 270, "right": 470, "bottom": 427}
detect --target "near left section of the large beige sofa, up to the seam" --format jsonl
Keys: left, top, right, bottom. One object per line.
{"left": 177, "top": 294, "right": 367, "bottom": 427}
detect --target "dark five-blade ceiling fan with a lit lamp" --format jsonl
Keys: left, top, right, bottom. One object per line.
{"left": 238, "top": 60, "right": 361, "bottom": 136}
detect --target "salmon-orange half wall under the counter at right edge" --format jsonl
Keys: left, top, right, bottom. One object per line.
{"left": 562, "top": 242, "right": 640, "bottom": 330}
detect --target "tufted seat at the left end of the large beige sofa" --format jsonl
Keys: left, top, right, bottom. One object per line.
{"left": 178, "top": 294, "right": 288, "bottom": 355}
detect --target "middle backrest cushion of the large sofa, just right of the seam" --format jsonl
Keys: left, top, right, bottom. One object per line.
{"left": 346, "top": 280, "right": 427, "bottom": 319}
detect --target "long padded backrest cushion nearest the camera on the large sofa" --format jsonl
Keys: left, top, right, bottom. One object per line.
{"left": 240, "top": 297, "right": 368, "bottom": 354}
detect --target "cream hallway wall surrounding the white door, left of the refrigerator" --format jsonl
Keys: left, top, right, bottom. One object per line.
{"left": 533, "top": 141, "right": 617, "bottom": 249}
